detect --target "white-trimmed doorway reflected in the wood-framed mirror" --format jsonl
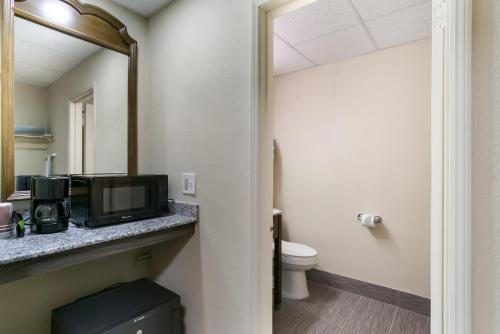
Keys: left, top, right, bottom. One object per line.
{"left": 69, "top": 90, "right": 95, "bottom": 174}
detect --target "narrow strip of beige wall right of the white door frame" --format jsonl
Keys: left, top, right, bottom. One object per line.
{"left": 471, "top": 0, "right": 500, "bottom": 334}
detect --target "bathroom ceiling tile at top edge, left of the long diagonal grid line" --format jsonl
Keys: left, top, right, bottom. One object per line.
{"left": 274, "top": 0, "right": 359, "bottom": 44}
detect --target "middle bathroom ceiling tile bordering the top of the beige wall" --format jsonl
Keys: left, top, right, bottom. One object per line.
{"left": 295, "top": 25, "right": 375, "bottom": 65}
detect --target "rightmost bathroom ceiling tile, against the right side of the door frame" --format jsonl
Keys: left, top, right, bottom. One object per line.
{"left": 366, "top": 1, "right": 432, "bottom": 48}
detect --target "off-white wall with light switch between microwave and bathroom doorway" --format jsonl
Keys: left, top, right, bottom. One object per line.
{"left": 148, "top": 0, "right": 251, "bottom": 334}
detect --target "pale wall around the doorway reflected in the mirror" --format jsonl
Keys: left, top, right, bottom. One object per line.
{"left": 48, "top": 49, "right": 128, "bottom": 173}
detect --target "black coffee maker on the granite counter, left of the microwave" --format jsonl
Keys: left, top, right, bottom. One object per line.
{"left": 31, "top": 176, "right": 71, "bottom": 234}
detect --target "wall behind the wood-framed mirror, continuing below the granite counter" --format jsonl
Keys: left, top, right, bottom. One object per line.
{"left": 0, "top": 0, "right": 150, "bottom": 334}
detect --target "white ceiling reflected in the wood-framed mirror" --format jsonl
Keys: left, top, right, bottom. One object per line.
{"left": 14, "top": 17, "right": 102, "bottom": 87}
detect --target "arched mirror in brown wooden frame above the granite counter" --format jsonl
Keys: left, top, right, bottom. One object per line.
{"left": 1, "top": 0, "right": 137, "bottom": 201}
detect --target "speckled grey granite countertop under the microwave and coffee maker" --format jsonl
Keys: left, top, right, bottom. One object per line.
{"left": 0, "top": 202, "right": 199, "bottom": 266}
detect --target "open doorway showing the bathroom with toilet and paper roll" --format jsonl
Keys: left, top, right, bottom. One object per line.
{"left": 260, "top": 0, "right": 444, "bottom": 333}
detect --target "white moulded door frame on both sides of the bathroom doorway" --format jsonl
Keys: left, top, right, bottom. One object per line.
{"left": 250, "top": 0, "right": 472, "bottom": 334}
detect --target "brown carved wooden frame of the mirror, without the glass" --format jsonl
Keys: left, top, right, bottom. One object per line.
{"left": 1, "top": 0, "right": 138, "bottom": 201}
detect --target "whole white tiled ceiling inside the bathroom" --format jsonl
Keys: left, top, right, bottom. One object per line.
{"left": 274, "top": 0, "right": 432, "bottom": 76}
